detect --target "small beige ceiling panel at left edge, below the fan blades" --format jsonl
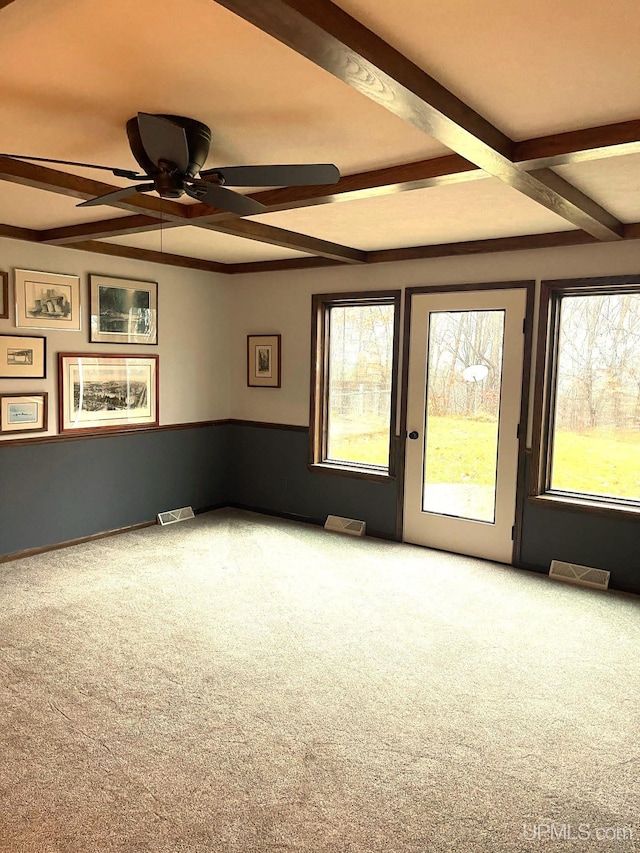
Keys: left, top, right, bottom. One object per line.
{"left": 0, "top": 181, "right": 131, "bottom": 231}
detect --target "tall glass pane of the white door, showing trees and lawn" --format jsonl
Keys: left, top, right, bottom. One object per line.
{"left": 422, "top": 311, "right": 504, "bottom": 522}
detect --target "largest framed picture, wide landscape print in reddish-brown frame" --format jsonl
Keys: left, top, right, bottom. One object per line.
{"left": 58, "top": 352, "right": 159, "bottom": 433}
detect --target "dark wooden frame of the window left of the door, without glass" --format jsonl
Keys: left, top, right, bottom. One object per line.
{"left": 308, "top": 290, "right": 402, "bottom": 481}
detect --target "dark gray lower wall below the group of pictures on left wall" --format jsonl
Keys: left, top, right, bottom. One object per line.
{"left": 0, "top": 424, "right": 230, "bottom": 555}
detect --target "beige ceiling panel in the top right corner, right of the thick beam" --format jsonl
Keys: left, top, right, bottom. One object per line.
{"left": 338, "top": 0, "right": 640, "bottom": 140}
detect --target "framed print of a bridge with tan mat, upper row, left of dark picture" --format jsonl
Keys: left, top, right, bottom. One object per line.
{"left": 15, "top": 270, "right": 81, "bottom": 332}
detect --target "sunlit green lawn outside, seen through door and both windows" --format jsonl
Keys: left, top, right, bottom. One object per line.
{"left": 331, "top": 417, "right": 640, "bottom": 500}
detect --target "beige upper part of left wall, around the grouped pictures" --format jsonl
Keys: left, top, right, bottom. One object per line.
{"left": 0, "top": 239, "right": 230, "bottom": 441}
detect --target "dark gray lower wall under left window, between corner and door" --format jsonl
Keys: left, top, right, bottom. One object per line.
{"left": 229, "top": 424, "right": 398, "bottom": 537}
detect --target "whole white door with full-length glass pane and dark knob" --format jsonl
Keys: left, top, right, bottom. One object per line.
{"left": 403, "top": 282, "right": 533, "bottom": 563}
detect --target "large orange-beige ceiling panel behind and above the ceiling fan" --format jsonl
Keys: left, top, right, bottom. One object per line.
{"left": 0, "top": 0, "right": 444, "bottom": 180}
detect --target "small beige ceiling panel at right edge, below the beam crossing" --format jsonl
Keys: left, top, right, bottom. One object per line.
{"left": 554, "top": 154, "right": 640, "bottom": 222}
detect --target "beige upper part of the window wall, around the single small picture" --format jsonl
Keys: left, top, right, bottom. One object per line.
{"left": 231, "top": 240, "right": 640, "bottom": 426}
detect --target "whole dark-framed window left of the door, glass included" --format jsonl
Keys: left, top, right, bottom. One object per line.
{"left": 310, "top": 291, "right": 400, "bottom": 478}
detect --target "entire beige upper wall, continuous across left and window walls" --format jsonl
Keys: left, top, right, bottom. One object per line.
{"left": 7, "top": 239, "right": 640, "bottom": 440}
